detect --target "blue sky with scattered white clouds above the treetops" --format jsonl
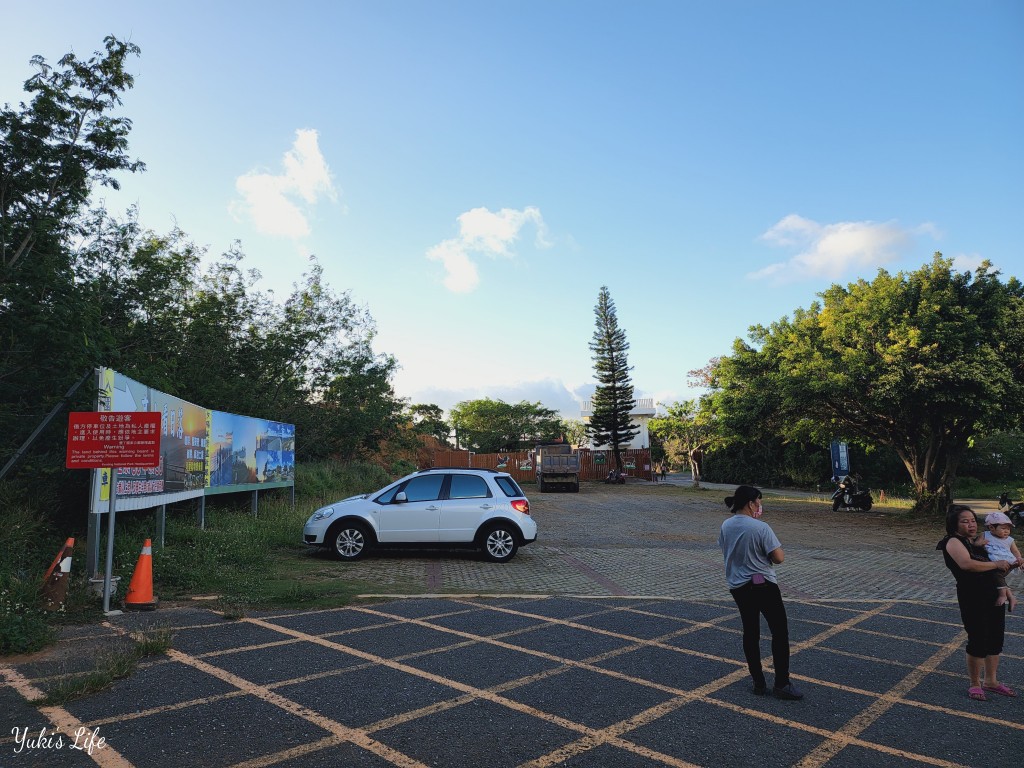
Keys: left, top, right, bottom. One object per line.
{"left": 0, "top": 0, "right": 1024, "bottom": 416}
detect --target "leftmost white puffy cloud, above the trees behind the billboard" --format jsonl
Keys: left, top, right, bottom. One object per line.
{"left": 231, "top": 129, "right": 338, "bottom": 239}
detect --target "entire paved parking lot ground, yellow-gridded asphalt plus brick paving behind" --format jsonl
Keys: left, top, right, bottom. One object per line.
{"left": 0, "top": 486, "right": 1024, "bottom": 768}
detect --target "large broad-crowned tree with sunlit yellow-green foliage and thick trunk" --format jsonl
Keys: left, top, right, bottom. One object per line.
{"left": 712, "top": 254, "right": 1024, "bottom": 515}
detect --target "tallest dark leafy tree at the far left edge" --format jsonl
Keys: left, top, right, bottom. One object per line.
{"left": 0, "top": 38, "right": 142, "bottom": 477}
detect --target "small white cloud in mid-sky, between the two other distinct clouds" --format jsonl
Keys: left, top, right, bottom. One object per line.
{"left": 427, "top": 206, "right": 551, "bottom": 293}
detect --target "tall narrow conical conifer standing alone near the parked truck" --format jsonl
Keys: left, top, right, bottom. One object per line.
{"left": 587, "top": 286, "right": 640, "bottom": 472}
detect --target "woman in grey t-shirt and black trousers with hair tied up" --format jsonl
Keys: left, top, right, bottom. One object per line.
{"left": 718, "top": 485, "right": 804, "bottom": 700}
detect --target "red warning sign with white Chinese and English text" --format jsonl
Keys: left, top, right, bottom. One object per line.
{"left": 67, "top": 411, "right": 161, "bottom": 469}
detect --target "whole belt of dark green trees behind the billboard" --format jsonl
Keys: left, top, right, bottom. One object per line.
{"left": 0, "top": 38, "right": 404, "bottom": 504}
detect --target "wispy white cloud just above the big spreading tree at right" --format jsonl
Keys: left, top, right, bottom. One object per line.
{"left": 746, "top": 214, "right": 925, "bottom": 281}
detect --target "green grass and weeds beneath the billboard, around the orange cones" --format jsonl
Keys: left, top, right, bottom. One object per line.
{"left": 0, "top": 462, "right": 393, "bottom": 655}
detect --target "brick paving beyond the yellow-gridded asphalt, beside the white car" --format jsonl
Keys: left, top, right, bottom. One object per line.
{"left": 345, "top": 483, "right": 954, "bottom": 600}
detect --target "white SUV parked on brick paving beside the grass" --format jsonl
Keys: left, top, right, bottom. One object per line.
{"left": 302, "top": 467, "right": 537, "bottom": 562}
